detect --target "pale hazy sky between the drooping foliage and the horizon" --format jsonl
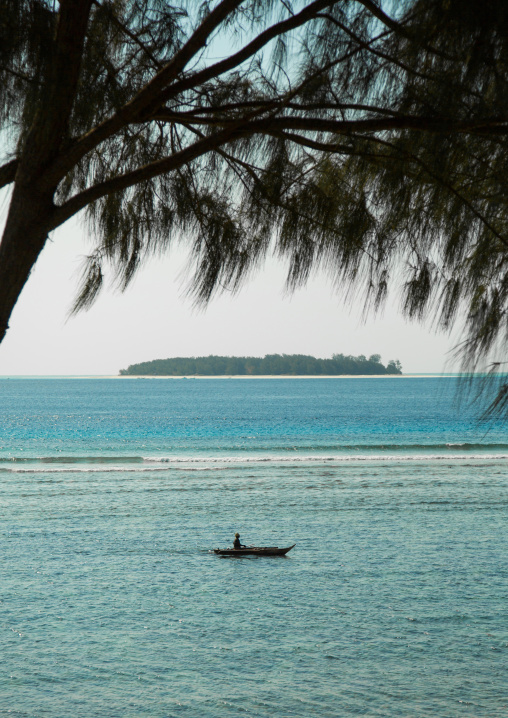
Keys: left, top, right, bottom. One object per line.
{"left": 0, "top": 191, "right": 460, "bottom": 376}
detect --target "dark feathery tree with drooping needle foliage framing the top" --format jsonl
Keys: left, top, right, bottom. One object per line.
{"left": 0, "top": 0, "right": 508, "bottom": 404}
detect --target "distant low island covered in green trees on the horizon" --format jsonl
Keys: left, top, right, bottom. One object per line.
{"left": 120, "top": 354, "right": 402, "bottom": 376}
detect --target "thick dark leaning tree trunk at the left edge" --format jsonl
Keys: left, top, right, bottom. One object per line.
{"left": 0, "top": 0, "right": 92, "bottom": 342}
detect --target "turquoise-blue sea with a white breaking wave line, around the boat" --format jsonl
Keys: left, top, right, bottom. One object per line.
{"left": 0, "top": 378, "right": 508, "bottom": 718}
